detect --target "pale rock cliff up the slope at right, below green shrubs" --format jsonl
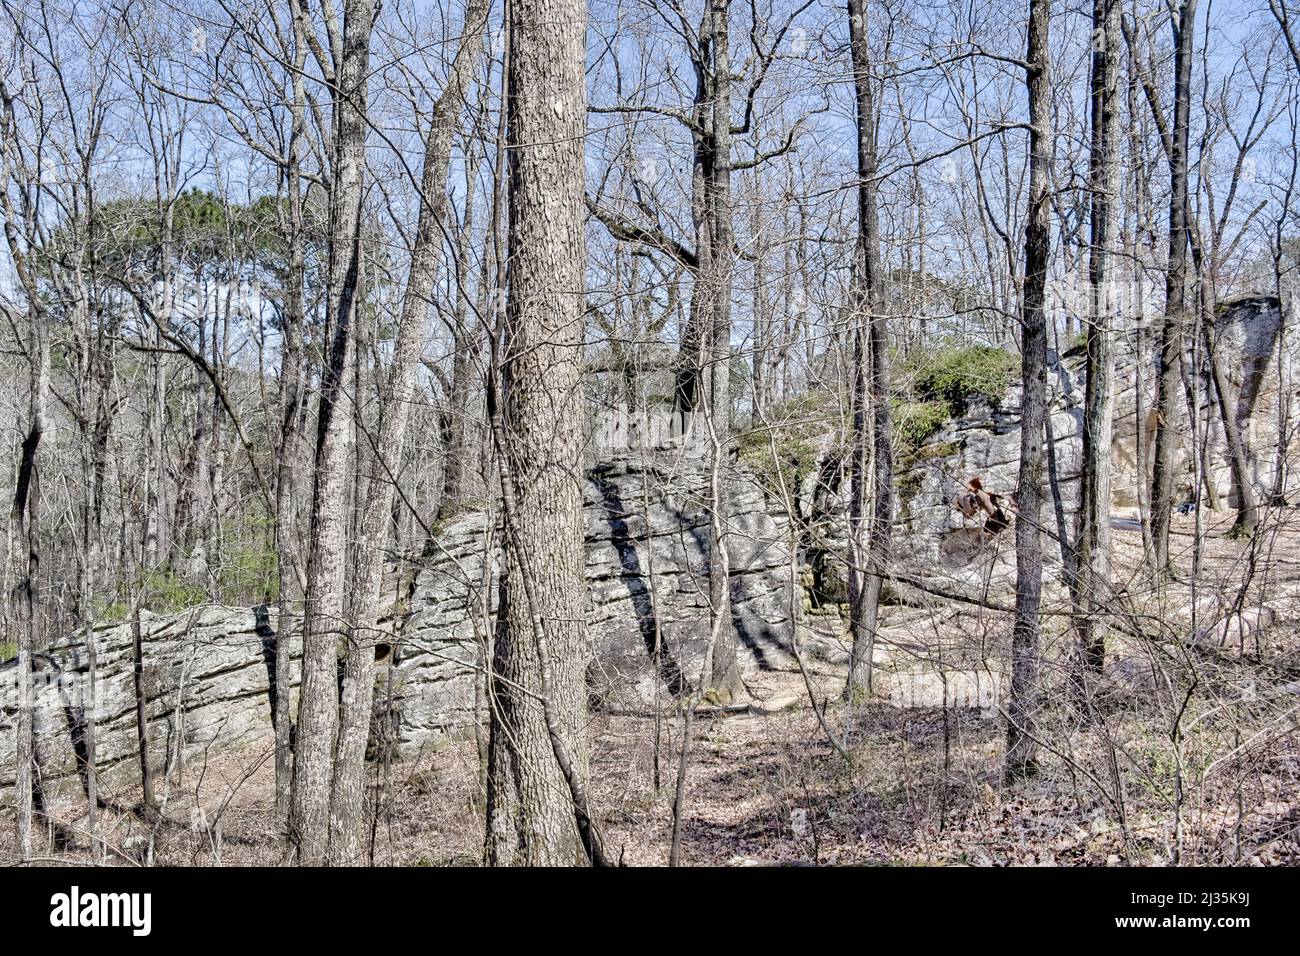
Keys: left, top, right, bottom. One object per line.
{"left": 883, "top": 297, "right": 1300, "bottom": 583}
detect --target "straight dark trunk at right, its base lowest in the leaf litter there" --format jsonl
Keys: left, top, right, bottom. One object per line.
{"left": 1006, "top": 0, "right": 1052, "bottom": 780}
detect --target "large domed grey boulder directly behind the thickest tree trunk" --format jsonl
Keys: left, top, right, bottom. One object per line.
{"left": 393, "top": 455, "right": 793, "bottom": 747}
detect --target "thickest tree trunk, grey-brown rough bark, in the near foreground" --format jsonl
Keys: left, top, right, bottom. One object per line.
{"left": 485, "top": 0, "right": 598, "bottom": 865}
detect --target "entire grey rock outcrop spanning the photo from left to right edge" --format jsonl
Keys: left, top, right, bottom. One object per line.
{"left": 0, "top": 299, "right": 1300, "bottom": 806}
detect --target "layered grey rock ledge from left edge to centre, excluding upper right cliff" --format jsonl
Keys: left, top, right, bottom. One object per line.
{"left": 0, "top": 458, "right": 793, "bottom": 795}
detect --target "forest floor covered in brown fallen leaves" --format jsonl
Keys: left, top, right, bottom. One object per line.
{"left": 0, "top": 510, "right": 1300, "bottom": 865}
